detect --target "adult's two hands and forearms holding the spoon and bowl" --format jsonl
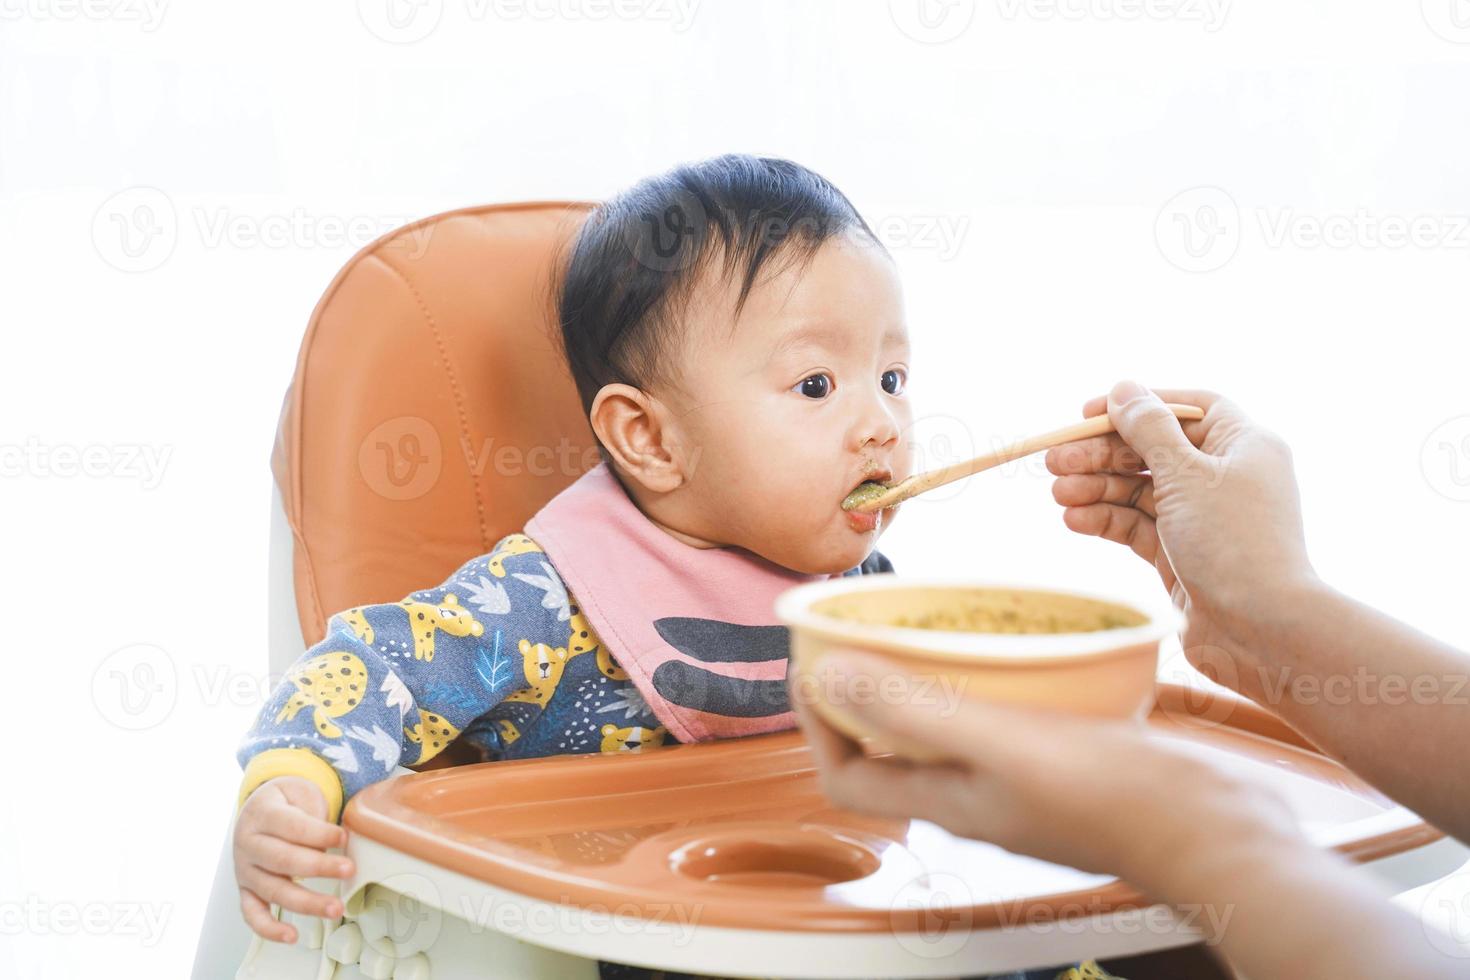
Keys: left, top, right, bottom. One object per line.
{"left": 784, "top": 382, "right": 1470, "bottom": 980}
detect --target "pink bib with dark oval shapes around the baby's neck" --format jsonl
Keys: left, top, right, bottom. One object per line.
{"left": 526, "top": 463, "right": 832, "bottom": 742}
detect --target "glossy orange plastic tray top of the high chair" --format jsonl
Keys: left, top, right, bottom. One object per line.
{"left": 344, "top": 685, "right": 1442, "bottom": 932}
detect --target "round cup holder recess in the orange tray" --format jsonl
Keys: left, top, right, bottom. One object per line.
{"left": 669, "top": 827, "right": 882, "bottom": 887}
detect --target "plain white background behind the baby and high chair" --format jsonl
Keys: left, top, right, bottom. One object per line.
{"left": 0, "top": 0, "right": 1470, "bottom": 979}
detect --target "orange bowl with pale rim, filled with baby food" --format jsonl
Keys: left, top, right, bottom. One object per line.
{"left": 776, "top": 574, "right": 1183, "bottom": 758}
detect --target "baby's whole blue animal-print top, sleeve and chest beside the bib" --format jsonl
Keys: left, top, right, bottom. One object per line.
{"left": 238, "top": 533, "right": 892, "bottom": 820}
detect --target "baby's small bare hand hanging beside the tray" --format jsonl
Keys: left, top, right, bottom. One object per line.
{"left": 235, "top": 776, "right": 353, "bottom": 943}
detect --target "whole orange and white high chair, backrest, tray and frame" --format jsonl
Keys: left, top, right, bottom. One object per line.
{"left": 194, "top": 203, "right": 1463, "bottom": 980}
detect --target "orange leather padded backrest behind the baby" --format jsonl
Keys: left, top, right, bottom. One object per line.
{"left": 270, "top": 203, "right": 598, "bottom": 645}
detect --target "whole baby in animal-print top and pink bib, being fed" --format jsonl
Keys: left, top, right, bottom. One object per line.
{"left": 234, "top": 156, "right": 1117, "bottom": 976}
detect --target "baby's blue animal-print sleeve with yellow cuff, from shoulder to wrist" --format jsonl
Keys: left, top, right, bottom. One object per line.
{"left": 237, "top": 535, "right": 595, "bottom": 815}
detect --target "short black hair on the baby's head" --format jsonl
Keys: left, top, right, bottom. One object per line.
{"left": 557, "top": 153, "right": 878, "bottom": 411}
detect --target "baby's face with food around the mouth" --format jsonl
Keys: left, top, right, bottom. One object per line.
{"left": 666, "top": 237, "right": 913, "bottom": 574}
